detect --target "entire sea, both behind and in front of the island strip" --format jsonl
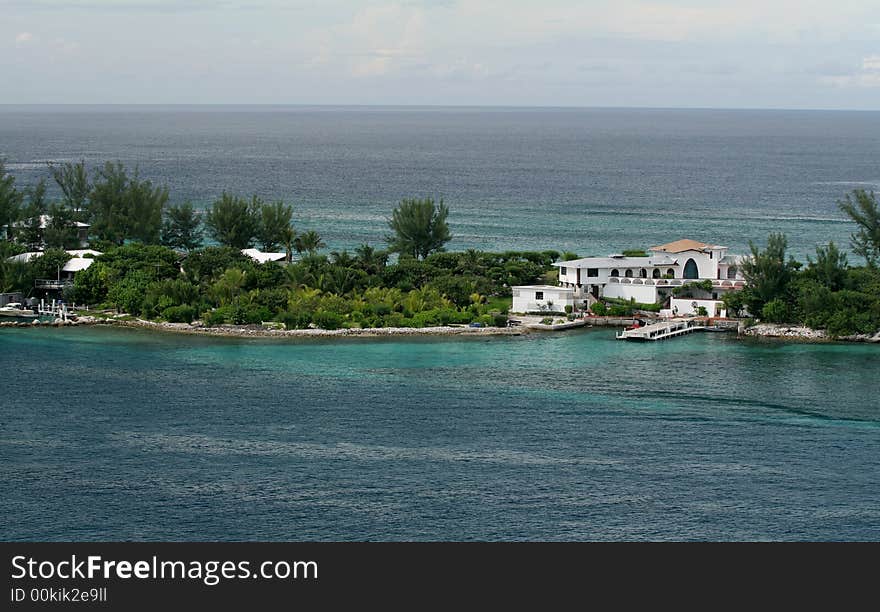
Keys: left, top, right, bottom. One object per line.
{"left": 0, "top": 107, "right": 880, "bottom": 540}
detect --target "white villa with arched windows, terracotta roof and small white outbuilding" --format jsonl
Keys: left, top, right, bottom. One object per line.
{"left": 511, "top": 240, "right": 745, "bottom": 316}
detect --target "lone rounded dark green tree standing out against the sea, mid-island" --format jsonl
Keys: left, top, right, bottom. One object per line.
{"left": 386, "top": 198, "right": 452, "bottom": 259}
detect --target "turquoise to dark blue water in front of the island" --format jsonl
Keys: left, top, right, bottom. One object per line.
{"left": 0, "top": 328, "right": 880, "bottom": 540}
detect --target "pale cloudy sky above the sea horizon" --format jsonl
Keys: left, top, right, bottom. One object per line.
{"left": 0, "top": 0, "right": 880, "bottom": 110}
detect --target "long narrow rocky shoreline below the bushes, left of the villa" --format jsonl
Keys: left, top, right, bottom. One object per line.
{"left": 0, "top": 316, "right": 527, "bottom": 338}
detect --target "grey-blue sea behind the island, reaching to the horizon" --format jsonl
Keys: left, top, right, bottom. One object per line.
{"left": 0, "top": 107, "right": 880, "bottom": 257}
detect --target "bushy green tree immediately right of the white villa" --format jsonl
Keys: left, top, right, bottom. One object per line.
{"left": 742, "top": 234, "right": 800, "bottom": 313}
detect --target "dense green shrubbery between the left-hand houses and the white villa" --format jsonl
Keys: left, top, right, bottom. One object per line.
{"left": 51, "top": 244, "right": 554, "bottom": 329}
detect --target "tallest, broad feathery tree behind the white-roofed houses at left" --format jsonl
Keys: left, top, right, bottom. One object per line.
{"left": 88, "top": 162, "right": 168, "bottom": 245}
